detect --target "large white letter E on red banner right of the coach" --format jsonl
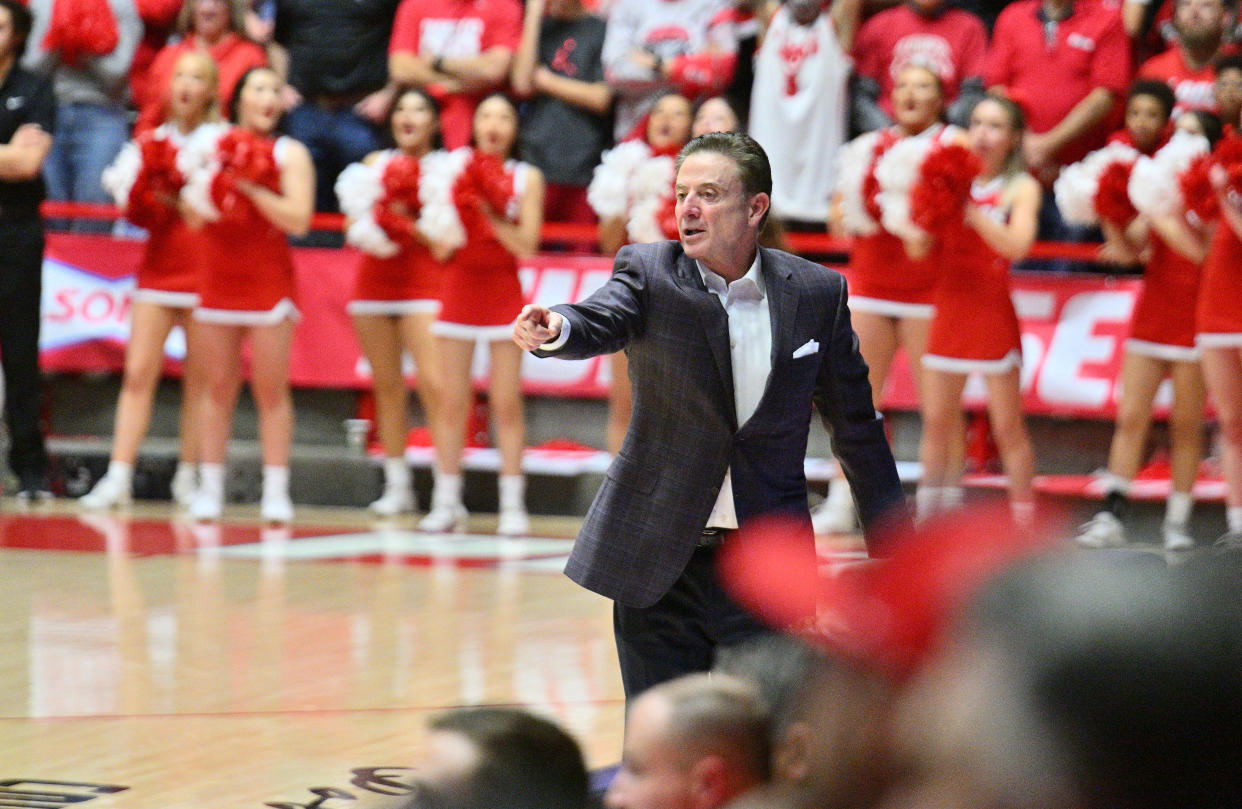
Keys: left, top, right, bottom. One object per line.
{"left": 1036, "top": 291, "right": 1134, "bottom": 410}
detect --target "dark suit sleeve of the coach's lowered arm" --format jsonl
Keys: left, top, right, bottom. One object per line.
{"left": 815, "top": 278, "right": 905, "bottom": 552}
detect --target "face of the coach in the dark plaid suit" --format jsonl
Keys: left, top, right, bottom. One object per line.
{"left": 674, "top": 152, "right": 768, "bottom": 280}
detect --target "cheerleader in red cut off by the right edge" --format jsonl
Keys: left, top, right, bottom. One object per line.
{"left": 1195, "top": 122, "right": 1242, "bottom": 552}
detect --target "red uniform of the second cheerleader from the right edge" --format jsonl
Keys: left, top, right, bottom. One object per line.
{"left": 1125, "top": 232, "right": 1201, "bottom": 362}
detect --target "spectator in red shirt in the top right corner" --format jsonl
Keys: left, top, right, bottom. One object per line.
{"left": 1136, "top": 0, "right": 1238, "bottom": 118}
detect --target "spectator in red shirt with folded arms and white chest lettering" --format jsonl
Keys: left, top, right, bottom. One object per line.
{"left": 389, "top": 0, "right": 522, "bottom": 149}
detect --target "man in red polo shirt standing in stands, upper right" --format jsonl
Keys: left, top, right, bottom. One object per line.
{"left": 984, "top": 0, "right": 1130, "bottom": 251}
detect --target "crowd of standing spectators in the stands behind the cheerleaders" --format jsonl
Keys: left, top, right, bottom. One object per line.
{"left": 12, "top": 0, "right": 1242, "bottom": 240}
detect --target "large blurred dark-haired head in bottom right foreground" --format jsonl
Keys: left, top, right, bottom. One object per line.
{"left": 884, "top": 554, "right": 1242, "bottom": 809}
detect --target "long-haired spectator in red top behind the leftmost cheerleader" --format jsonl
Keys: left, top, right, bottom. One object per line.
{"left": 134, "top": 0, "right": 267, "bottom": 134}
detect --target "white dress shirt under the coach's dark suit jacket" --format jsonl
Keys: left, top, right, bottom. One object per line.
{"left": 696, "top": 251, "right": 773, "bottom": 528}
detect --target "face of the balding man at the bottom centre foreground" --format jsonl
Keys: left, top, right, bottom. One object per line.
{"left": 604, "top": 695, "right": 693, "bottom": 809}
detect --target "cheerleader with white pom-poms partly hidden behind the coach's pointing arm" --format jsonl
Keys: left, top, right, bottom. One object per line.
{"left": 586, "top": 93, "right": 695, "bottom": 455}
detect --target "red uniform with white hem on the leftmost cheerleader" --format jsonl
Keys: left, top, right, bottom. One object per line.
{"left": 133, "top": 124, "right": 204, "bottom": 309}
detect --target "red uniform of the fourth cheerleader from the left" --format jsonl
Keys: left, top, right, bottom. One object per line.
{"left": 432, "top": 153, "right": 529, "bottom": 342}
